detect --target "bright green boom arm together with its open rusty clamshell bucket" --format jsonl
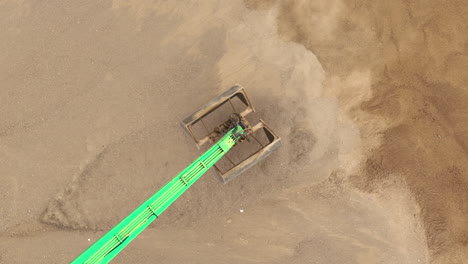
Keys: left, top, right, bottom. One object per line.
{"left": 72, "top": 85, "right": 281, "bottom": 264}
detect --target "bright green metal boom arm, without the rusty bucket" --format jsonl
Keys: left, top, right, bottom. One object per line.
{"left": 72, "top": 125, "right": 244, "bottom": 264}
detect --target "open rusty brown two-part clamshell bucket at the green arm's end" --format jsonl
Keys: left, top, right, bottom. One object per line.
{"left": 181, "top": 85, "right": 281, "bottom": 183}
